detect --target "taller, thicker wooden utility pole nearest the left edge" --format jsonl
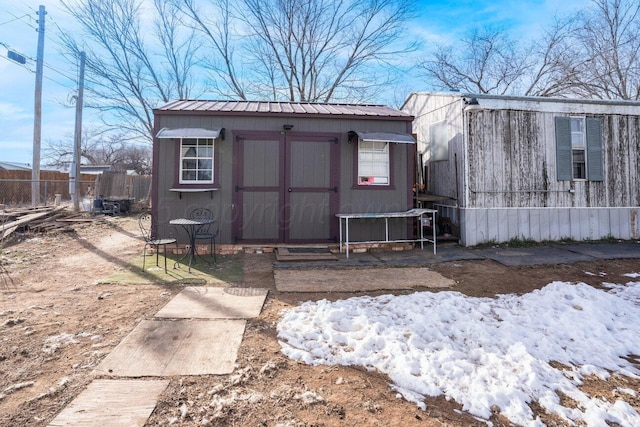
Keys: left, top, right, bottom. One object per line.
{"left": 31, "top": 5, "right": 47, "bottom": 207}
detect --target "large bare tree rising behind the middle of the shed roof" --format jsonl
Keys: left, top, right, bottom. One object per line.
{"left": 173, "top": 0, "right": 414, "bottom": 102}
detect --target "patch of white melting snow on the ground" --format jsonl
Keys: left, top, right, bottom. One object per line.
{"left": 278, "top": 273, "right": 640, "bottom": 426}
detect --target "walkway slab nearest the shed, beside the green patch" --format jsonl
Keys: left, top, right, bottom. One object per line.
{"left": 155, "top": 286, "right": 269, "bottom": 319}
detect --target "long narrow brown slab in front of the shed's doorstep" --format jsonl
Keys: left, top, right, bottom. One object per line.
{"left": 273, "top": 267, "right": 455, "bottom": 292}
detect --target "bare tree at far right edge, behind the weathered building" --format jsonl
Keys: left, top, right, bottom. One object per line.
{"left": 574, "top": 0, "right": 640, "bottom": 100}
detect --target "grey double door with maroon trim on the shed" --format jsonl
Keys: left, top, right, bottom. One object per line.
{"left": 233, "top": 133, "right": 339, "bottom": 243}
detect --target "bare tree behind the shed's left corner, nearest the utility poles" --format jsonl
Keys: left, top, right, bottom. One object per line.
{"left": 61, "top": 0, "right": 197, "bottom": 141}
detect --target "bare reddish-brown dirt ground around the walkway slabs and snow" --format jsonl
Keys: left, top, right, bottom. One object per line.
{"left": 0, "top": 218, "right": 640, "bottom": 427}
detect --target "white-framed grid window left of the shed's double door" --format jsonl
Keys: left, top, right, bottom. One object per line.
{"left": 180, "top": 138, "right": 214, "bottom": 184}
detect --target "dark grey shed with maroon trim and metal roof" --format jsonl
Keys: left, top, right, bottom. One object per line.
{"left": 152, "top": 100, "right": 415, "bottom": 244}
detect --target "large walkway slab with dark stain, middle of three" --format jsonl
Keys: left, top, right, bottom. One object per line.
{"left": 97, "top": 320, "right": 246, "bottom": 377}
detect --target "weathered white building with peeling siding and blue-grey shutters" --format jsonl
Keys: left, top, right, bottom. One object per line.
{"left": 402, "top": 92, "right": 640, "bottom": 246}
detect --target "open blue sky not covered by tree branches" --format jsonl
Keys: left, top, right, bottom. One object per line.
{"left": 0, "top": 0, "right": 588, "bottom": 164}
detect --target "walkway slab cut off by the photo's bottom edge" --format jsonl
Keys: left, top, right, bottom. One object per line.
{"left": 49, "top": 380, "right": 169, "bottom": 427}
